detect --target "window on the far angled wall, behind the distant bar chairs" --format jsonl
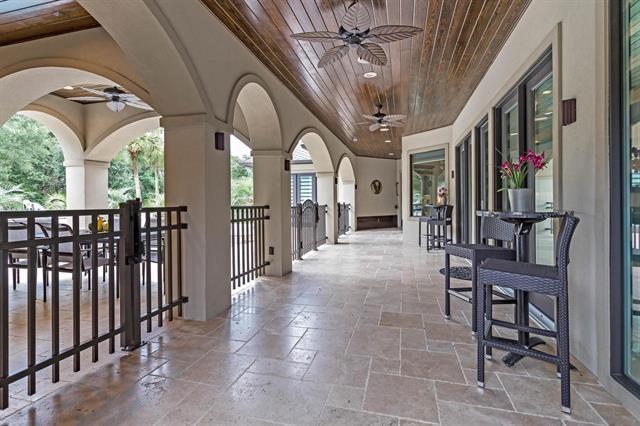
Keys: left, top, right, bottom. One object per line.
{"left": 409, "top": 148, "right": 447, "bottom": 216}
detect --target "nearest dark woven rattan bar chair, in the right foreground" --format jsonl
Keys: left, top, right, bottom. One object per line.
{"left": 477, "top": 214, "right": 580, "bottom": 413}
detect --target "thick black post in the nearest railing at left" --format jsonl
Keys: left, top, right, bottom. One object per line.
{"left": 118, "top": 200, "right": 142, "bottom": 351}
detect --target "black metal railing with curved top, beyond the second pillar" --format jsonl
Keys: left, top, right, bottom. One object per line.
{"left": 291, "top": 200, "right": 327, "bottom": 260}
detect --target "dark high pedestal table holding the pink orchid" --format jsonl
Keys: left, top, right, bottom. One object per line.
{"left": 476, "top": 210, "right": 565, "bottom": 367}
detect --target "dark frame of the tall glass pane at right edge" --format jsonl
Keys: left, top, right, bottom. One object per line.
{"left": 609, "top": 0, "right": 640, "bottom": 398}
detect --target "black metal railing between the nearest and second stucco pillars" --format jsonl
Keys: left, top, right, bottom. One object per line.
{"left": 231, "top": 206, "right": 269, "bottom": 290}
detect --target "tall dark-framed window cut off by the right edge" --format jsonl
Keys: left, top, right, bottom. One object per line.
{"left": 610, "top": 0, "right": 640, "bottom": 397}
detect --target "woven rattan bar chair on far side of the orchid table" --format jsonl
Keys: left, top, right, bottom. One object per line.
{"left": 444, "top": 217, "right": 516, "bottom": 333}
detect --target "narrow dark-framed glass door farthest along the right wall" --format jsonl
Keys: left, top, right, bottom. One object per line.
{"left": 456, "top": 135, "right": 473, "bottom": 243}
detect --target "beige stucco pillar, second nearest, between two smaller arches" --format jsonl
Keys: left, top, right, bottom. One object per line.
{"left": 251, "top": 150, "right": 291, "bottom": 276}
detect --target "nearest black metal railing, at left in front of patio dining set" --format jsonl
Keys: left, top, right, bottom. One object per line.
{"left": 0, "top": 201, "right": 187, "bottom": 409}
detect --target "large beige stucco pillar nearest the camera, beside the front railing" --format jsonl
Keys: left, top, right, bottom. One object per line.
{"left": 160, "top": 114, "right": 231, "bottom": 320}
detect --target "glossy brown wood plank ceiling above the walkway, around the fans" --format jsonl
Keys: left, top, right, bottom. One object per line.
{"left": 201, "top": 0, "right": 530, "bottom": 158}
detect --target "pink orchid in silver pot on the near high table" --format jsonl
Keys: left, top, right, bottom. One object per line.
{"left": 500, "top": 149, "right": 548, "bottom": 212}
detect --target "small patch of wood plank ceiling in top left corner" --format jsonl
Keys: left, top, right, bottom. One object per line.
{"left": 0, "top": 0, "right": 100, "bottom": 46}
